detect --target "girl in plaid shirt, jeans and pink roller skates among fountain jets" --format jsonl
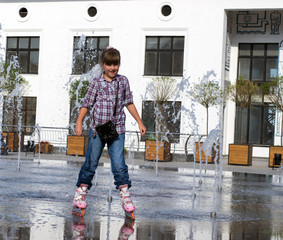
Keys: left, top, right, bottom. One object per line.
{"left": 73, "top": 48, "right": 146, "bottom": 217}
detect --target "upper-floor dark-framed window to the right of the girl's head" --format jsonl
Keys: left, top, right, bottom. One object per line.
{"left": 144, "top": 37, "right": 184, "bottom": 76}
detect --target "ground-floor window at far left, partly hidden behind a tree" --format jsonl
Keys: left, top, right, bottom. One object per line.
{"left": 3, "top": 97, "right": 36, "bottom": 133}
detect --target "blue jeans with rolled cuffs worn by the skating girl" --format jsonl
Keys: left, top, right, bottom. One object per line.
{"left": 76, "top": 129, "right": 131, "bottom": 189}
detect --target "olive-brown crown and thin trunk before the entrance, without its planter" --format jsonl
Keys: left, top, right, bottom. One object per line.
{"left": 226, "top": 77, "right": 260, "bottom": 144}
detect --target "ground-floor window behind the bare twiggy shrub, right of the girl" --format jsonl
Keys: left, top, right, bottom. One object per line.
{"left": 142, "top": 101, "right": 181, "bottom": 142}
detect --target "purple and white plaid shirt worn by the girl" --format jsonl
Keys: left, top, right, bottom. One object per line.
{"left": 81, "top": 74, "right": 133, "bottom": 134}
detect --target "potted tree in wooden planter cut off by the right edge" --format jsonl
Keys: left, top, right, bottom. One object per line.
{"left": 261, "top": 77, "right": 283, "bottom": 167}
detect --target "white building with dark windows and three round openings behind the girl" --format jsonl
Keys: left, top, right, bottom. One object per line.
{"left": 0, "top": 0, "right": 283, "bottom": 156}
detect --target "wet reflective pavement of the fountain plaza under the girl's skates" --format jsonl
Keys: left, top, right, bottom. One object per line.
{"left": 0, "top": 154, "right": 283, "bottom": 240}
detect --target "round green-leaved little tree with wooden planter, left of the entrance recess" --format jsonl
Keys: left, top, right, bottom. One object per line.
{"left": 192, "top": 79, "right": 222, "bottom": 163}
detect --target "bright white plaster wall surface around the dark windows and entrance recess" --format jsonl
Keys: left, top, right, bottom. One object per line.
{"left": 0, "top": 0, "right": 283, "bottom": 154}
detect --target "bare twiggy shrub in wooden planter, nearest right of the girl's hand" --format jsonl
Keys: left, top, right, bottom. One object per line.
{"left": 145, "top": 76, "right": 176, "bottom": 161}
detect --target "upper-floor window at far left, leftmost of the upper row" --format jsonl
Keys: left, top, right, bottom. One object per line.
{"left": 6, "top": 37, "right": 39, "bottom": 74}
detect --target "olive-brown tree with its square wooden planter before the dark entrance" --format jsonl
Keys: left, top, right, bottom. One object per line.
{"left": 226, "top": 77, "right": 259, "bottom": 166}
